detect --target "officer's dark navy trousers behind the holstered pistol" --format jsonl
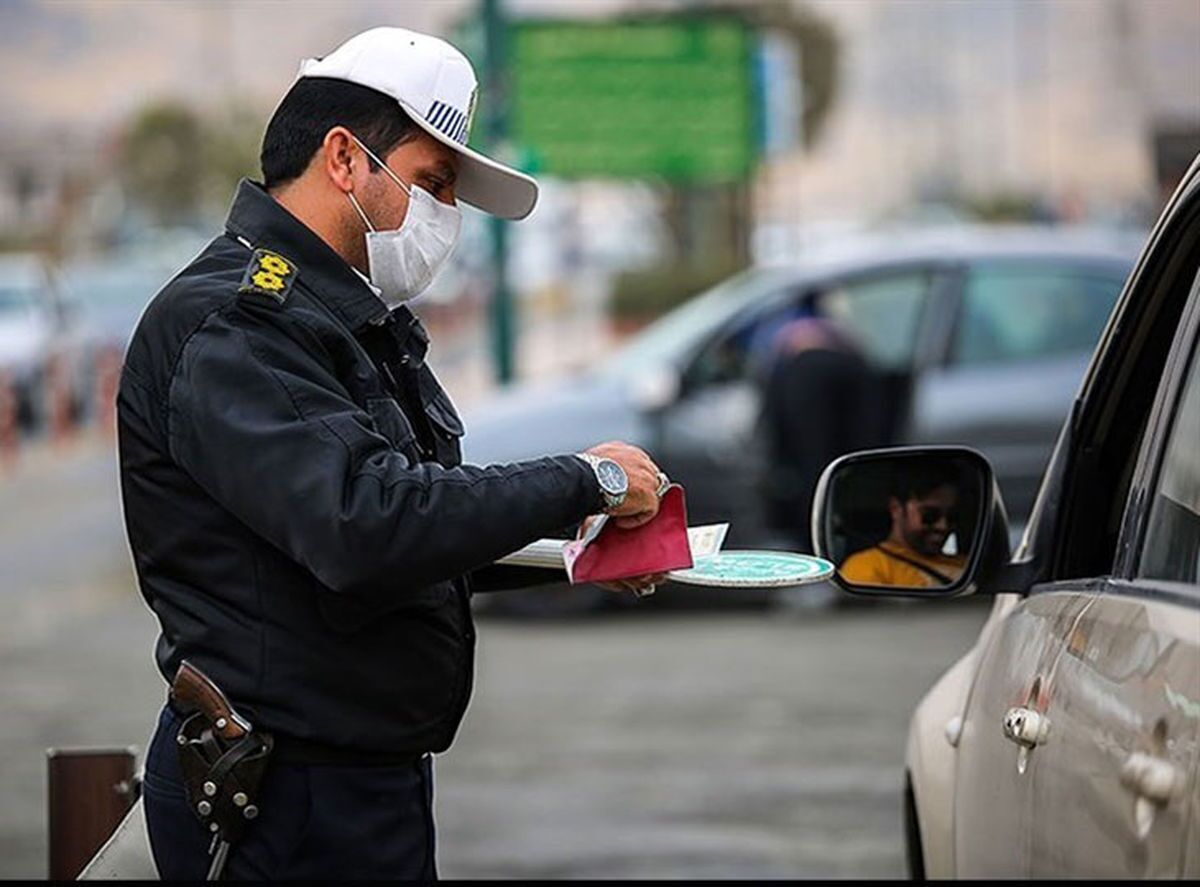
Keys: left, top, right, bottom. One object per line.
{"left": 143, "top": 707, "right": 437, "bottom": 881}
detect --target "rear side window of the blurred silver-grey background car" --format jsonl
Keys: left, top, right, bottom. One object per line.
{"left": 953, "top": 265, "right": 1124, "bottom": 366}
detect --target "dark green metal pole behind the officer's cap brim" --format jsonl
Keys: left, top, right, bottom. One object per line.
{"left": 482, "top": 0, "right": 515, "bottom": 385}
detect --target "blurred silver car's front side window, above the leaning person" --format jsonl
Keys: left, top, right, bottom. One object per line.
{"left": 820, "top": 271, "right": 930, "bottom": 370}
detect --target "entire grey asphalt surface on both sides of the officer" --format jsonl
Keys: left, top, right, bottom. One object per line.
{"left": 0, "top": 439, "right": 986, "bottom": 879}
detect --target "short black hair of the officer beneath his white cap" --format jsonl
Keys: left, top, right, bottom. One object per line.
{"left": 260, "top": 77, "right": 419, "bottom": 191}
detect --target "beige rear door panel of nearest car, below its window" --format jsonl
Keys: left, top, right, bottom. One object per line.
{"left": 1030, "top": 582, "right": 1200, "bottom": 879}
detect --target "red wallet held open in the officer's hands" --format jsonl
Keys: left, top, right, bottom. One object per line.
{"left": 563, "top": 484, "right": 692, "bottom": 585}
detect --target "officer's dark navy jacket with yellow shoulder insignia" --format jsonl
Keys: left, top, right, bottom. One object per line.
{"left": 118, "top": 181, "right": 601, "bottom": 760}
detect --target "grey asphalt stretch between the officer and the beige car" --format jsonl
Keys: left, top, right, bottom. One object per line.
{"left": 439, "top": 604, "right": 985, "bottom": 879}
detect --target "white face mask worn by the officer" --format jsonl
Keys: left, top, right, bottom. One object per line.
{"left": 347, "top": 138, "right": 462, "bottom": 308}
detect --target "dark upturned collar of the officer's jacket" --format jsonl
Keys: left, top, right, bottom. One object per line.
{"left": 226, "top": 179, "right": 391, "bottom": 332}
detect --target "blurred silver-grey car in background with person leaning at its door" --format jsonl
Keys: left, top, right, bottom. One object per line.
{"left": 464, "top": 228, "right": 1140, "bottom": 605}
